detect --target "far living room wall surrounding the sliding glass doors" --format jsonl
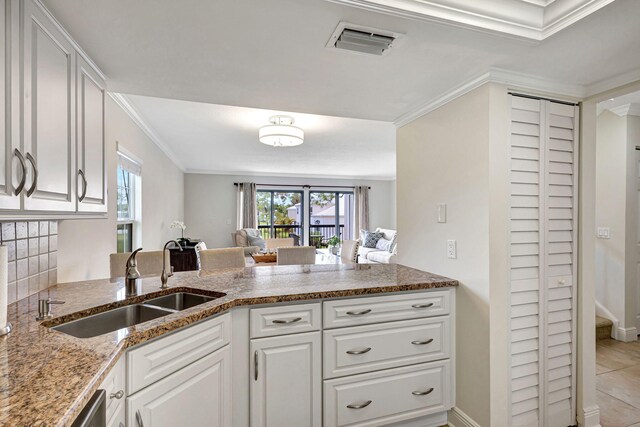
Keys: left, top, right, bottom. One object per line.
{"left": 184, "top": 174, "right": 396, "bottom": 248}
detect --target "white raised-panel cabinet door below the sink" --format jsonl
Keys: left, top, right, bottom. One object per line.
{"left": 127, "top": 346, "right": 231, "bottom": 427}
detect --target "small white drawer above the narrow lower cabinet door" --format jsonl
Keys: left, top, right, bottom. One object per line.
{"left": 250, "top": 303, "right": 322, "bottom": 338}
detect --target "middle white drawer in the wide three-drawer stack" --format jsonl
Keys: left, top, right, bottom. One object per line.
{"left": 323, "top": 316, "right": 451, "bottom": 378}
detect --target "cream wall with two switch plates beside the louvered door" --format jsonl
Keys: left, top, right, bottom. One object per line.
{"left": 396, "top": 85, "right": 492, "bottom": 426}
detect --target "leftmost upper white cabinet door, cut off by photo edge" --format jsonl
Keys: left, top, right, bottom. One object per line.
{"left": 0, "top": 0, "right": 23, "bottom": 209}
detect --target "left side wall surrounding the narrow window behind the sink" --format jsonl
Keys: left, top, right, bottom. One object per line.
{"left": 58, "top": 97, "right": 184, "bottom": 283}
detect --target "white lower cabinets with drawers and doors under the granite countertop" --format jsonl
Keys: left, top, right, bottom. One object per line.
{"left": 95, "top": 289, "right": 455, "bottom": 427}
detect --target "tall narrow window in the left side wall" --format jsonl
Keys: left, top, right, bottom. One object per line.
{"left": 116, "top": 152, "right": 141, "bottom": 252}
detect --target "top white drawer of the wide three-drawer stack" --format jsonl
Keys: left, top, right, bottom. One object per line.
{"left": 324, "top": 290, "right": 451, "bottom": 328}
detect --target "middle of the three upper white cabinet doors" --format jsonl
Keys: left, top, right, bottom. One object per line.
{"left": 21, "top": 0, "right": 76, "bottom": 211}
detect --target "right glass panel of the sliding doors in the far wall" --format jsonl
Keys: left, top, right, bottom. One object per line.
{"left": 308, "top": 191, "right": 354, "bottom": 248}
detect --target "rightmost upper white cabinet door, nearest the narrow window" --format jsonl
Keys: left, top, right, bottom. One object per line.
{"left": 75, "top": 55, "right": 107, "bottom": 212}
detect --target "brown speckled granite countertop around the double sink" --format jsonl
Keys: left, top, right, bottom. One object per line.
{"left": 0, "top": 264, "right": 458, "bottom": 427}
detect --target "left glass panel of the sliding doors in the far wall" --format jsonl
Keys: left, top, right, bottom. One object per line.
{"left": 256, "top": 190, "right": 304, "bottom": 240}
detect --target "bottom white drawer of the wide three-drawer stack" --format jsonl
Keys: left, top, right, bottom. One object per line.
{"left": 324, "top": 360, "right": 451, "bottom": 427}
